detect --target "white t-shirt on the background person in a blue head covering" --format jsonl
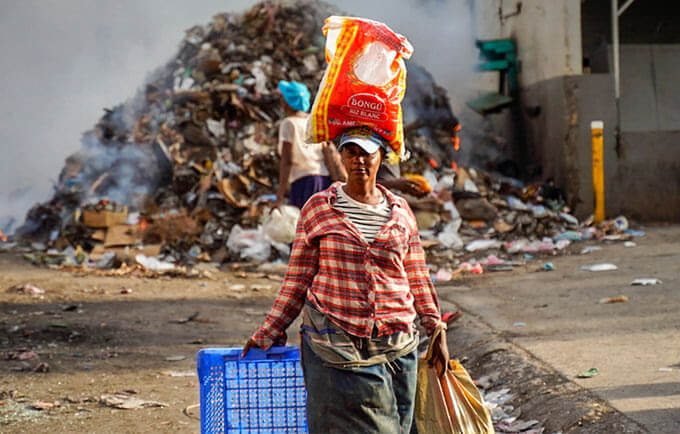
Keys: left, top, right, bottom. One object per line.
{"left": 278, "top": 115, "right": 328, "bottom": 183}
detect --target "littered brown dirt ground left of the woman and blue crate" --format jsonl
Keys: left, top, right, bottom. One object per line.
{"left": 0, "top": 253, "right": 280, "bottom": 433}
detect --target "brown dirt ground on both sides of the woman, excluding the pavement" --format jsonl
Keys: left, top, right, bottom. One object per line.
{"left": 0, "top": 242, "right": 643, "bottom": 433}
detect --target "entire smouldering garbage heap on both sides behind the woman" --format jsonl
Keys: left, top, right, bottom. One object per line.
{"left": 5, "top": 1, "right": 640, "bottom": 279}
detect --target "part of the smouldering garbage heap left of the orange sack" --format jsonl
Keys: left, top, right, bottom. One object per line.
{"left": 5, "top": 2, "right": 453, "bottom": 268}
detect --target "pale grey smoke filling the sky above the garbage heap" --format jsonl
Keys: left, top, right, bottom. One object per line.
{"left": 0, "top": 0, "right": 476, "bottom": 231}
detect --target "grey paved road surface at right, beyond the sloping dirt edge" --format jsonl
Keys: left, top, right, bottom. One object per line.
{"left": 439, "top": 226, "right": 680, "bottom": 433}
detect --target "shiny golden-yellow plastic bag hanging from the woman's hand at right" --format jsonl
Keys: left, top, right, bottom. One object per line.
{"left": 414, "top": 330, "right": 495, "bottom": 434}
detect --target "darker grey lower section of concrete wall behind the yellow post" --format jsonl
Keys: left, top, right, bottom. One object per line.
{"left": 522, "top": 74, "right": 680, "bottom": 221}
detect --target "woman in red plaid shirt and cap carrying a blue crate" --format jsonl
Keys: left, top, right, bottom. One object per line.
{"left": 243, "top": 129, "right": 448, "bottom": 433}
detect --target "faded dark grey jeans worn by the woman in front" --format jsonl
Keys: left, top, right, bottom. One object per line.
{"left": 301, "top": 335, "right": 418, "bottom": 434}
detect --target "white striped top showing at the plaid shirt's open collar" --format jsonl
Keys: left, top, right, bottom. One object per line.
{"left": 333, "top": 186, "right": 392, "bottom": 244}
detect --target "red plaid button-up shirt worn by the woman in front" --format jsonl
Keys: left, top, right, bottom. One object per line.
{"left": 253, "top": 183, "right": 441, "bottom": 348}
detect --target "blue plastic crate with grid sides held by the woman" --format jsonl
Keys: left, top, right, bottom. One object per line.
{"left": 196, "top": 347, "right": 307, "bottom": 433}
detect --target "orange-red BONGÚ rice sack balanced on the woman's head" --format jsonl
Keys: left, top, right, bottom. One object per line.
{"left": 307, "top": 16, "right": 413, "bottom": 157}
